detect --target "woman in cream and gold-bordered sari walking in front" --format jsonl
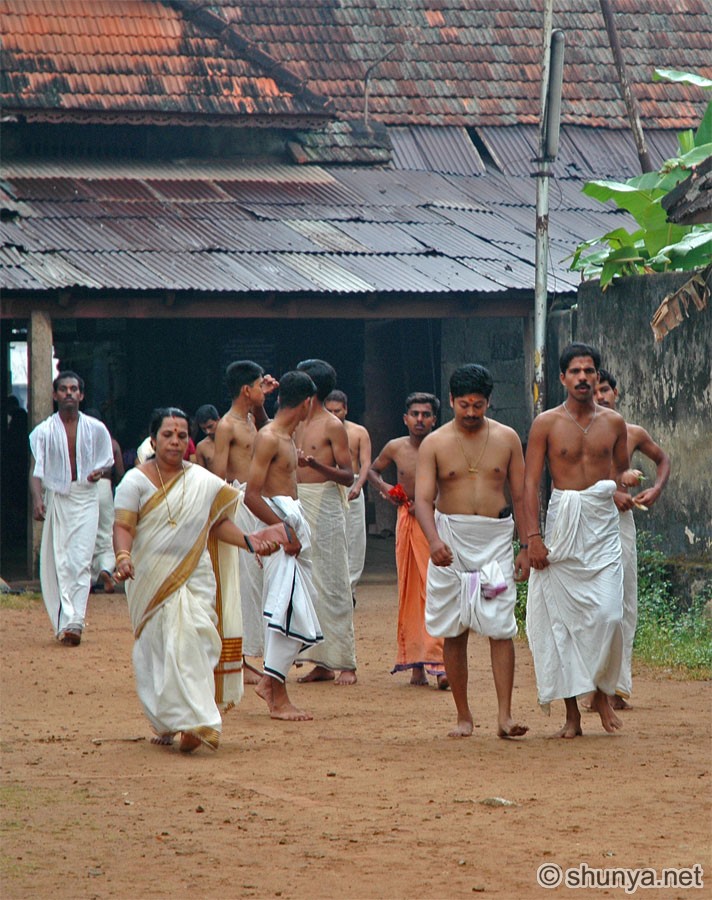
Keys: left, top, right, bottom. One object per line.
{"left": 114, "top": 407, "right": 287, "bottom": 752}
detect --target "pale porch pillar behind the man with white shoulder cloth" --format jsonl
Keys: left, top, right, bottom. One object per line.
{"left": 27, "top": 312, "right": 53, "bottom": 578}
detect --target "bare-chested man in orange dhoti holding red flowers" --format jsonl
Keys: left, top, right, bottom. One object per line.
{"left": 368, "top": 391, "right": 448, "bottom": 690}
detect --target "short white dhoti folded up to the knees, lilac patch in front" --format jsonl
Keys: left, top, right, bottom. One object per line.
{"left": 425, "top": 510, "right": 517, "bottom": 640}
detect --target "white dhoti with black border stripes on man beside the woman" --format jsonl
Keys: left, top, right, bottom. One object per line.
{"left": 258, "top": 497, "right": 324, "bottom": 682}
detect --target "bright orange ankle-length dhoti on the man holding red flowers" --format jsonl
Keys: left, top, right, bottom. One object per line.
{"left": 392, "top": 505, "right": 445, "bottom": 675}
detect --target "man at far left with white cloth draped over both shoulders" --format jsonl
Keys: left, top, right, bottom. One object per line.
{"left": 30, "top": 372, "right": 114, "bottom": 647}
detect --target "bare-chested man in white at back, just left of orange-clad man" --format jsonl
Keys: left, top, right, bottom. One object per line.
{"left": 324, "top": 391, "right": 371, "bottom": 606}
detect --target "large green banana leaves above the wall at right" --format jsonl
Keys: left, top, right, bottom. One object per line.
{"left": 570, "top": 69, "right": 712, "bottom": 289}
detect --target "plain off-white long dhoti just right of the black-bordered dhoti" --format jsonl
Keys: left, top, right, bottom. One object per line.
{"left": 298, "top": 481, "right": 356, "bottom": 671}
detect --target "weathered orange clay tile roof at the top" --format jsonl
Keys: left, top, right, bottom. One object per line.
{"left": 0, "top": 0, "right": 712, "bottom": 129}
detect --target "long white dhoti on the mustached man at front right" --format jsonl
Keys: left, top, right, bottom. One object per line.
{"left": 527, "top": 480, "right": 623, "bottom": 711}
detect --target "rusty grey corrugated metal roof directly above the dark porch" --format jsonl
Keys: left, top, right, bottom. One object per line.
{"left": 0, "top": 161, "right": 627, "bottom": 295}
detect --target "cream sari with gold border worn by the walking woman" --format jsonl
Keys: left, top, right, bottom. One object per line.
{"left": 115, "top": 465, "right": 242, "bottom": 749}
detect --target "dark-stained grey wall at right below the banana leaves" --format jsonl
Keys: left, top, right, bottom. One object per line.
{"left": 575, "top": 273, "right": 712, "bottom": 557}
